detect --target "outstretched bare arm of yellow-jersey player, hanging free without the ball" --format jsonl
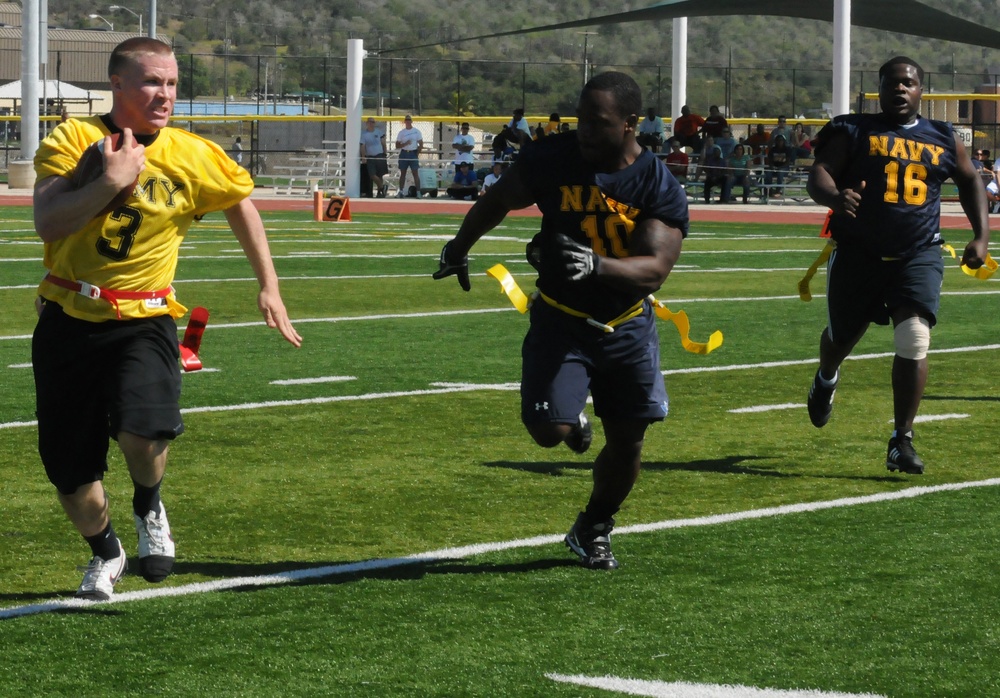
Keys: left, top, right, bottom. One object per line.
{"left": 225, "top": 198, "right": 302, "bottom": 347}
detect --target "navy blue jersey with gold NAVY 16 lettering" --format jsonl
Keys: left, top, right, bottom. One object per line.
{"left": 816, "top": 114, "right": 957, "bottom": 258}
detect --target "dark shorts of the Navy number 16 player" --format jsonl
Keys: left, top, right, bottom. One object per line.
{"left": 826, "top": 244, "right": 944, "bottom": 342}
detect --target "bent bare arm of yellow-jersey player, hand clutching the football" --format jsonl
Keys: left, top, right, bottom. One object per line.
{"left": 33, "top": 129, "right": 146, "bottom": 242}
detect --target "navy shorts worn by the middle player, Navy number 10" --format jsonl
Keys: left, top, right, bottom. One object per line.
{"left": 521, "top": 299, "right": 667, "bottom": 424}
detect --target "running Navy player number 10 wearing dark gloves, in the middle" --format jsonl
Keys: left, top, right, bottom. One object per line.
{"left": 434, "top": 72, "right": 688, "bottom": 569}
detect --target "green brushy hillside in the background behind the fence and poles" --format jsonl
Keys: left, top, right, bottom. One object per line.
{"left": 49, "top": 0, "right": 1000, "bottom": 116}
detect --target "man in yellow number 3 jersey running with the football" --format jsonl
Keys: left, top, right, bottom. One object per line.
{"left": 32, "top": 37, "right": 302, "bottom": 600}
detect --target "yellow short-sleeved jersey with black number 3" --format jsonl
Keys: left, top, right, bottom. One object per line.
{"left": 35, "top": 116, "right": 253, "bottom": 322}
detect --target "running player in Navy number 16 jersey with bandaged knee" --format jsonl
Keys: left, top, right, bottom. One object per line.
{"left": 808, "top": 56, "right": 990, "bottom": 475}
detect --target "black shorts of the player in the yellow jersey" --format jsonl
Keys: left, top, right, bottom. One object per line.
{"left": 31, "top": 302, "right": 184, "bottom": 494}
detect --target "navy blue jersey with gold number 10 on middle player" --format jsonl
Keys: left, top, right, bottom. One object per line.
{"left": 517, "top": 131, "right": 688, "bottom": 322}
